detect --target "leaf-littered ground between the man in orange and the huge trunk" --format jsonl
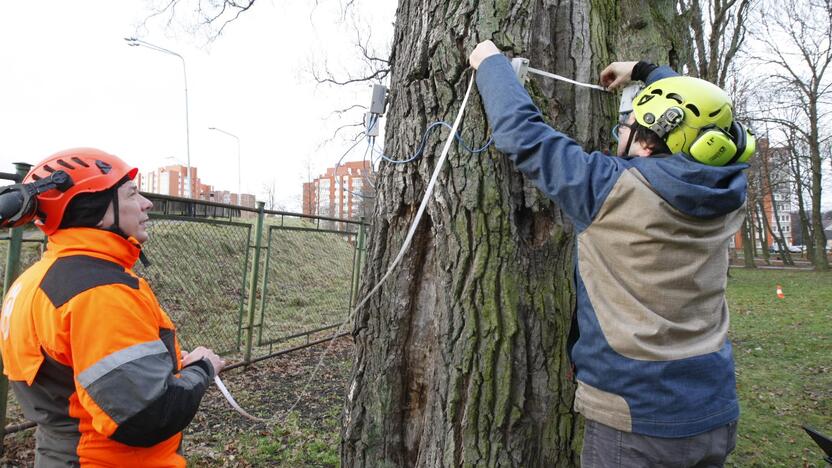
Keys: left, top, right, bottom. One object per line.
{"left": 180, "top": 339, "right": 353, "bottom": 468}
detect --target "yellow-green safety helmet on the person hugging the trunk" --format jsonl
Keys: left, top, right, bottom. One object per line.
{"left": 633, "top": 76, "right": 736, "bottom": 165}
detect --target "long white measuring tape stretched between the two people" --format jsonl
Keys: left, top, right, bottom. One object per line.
{"left": 214, "top": 58, "right": 608, "bottom": 422}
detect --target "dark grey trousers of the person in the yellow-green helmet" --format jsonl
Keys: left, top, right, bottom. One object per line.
{"left": 581, "top": 420, "right": 737, "bottom": 468}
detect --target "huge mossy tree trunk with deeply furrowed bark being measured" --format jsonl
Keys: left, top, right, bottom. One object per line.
{"left": 341, "top": 0, "right": 678, "bottom": 467}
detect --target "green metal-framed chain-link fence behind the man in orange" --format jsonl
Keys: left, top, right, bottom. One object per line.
{"left": 0, "top": 189, "right": 366, "bottom": 442}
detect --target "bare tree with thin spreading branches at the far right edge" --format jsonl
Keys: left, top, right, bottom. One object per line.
{"left": 754, "top": 0, "right": 832, "bottom": 270}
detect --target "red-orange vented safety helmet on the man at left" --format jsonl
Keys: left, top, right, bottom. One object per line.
{"left": 23, "top": 148, "right": 138, "bottom": 236}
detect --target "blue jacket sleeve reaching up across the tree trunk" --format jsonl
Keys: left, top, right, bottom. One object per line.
{"left": 477, "top": 55, "right": 628, "bottom": 230}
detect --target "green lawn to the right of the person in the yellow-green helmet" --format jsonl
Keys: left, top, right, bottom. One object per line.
{"left": 728, "top": 269, "right": 832, "bottom": 467}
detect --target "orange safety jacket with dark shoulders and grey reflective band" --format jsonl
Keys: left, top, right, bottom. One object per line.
{"left": 0, "top": 228, "right": 214, "bottom": 468}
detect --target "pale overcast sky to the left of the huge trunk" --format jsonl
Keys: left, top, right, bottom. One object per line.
{"left": 0, "top": 0, "right": 396, "bottom": 210}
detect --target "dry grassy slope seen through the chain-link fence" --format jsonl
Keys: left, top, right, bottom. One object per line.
{"left": 136, "top": 219, "right": 354, "bottom": 355}
